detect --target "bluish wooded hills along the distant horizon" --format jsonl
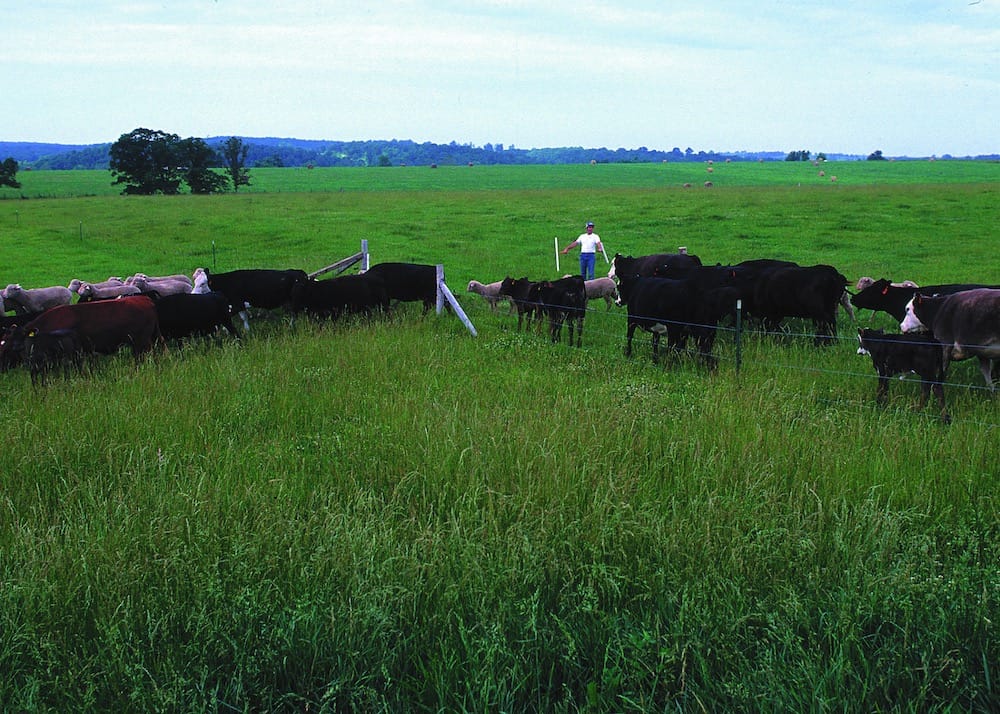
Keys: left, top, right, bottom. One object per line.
{"left": 0, "top": 137, "right": 1000, "bottom": 170}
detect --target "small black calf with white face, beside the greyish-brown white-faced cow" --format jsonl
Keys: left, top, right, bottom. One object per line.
{"left": 858, "top": 327, "right": 951, "bottom": 424}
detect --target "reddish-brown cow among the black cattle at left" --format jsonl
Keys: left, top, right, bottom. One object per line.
{"left": 15, "top": 295, "right": 160, "bottom": 361}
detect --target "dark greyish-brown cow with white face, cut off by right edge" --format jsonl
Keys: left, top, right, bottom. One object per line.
{"left": 899, "top": 288, "right": 1000, "bottom": 390}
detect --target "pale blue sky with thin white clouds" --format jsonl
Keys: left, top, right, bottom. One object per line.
{"left": 0, "top": 0, "right": 1000, "bottom": 156}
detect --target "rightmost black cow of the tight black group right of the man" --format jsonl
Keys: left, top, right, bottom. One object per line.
{"left": 752, "top": 265, "right": 847, "bottom": 345}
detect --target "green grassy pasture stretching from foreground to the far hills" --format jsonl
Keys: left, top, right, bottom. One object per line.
{"left": 0, "top": 161, "right": 1000, "bottom": 712}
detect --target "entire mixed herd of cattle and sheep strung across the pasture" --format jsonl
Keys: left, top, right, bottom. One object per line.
{"left": 0, "top": 253, "right": 1000, "bottom": 421}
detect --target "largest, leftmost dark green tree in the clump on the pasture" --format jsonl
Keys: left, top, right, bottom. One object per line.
{"left": 108, "top": 128, "right": 184, "bottom": 196}
